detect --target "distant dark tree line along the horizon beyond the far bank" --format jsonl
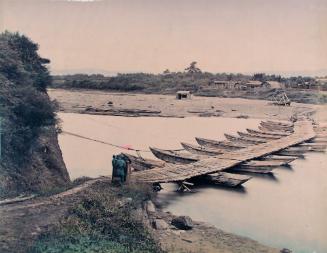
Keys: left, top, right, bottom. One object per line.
{"left": 52, "top": 61, "right": 327, "bottom": 93}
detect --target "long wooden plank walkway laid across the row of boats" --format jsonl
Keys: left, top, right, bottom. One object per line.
{"left": 132, "top": 120, "right": 315, "bottom": 183}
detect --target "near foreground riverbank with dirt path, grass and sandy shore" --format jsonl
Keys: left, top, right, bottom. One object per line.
{"left": 0, "top": 177, "right": 279, "bottom": 253}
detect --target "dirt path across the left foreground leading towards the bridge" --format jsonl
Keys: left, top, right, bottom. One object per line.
{"left": 0, "top": 178, "right": 105, "bottom": 253}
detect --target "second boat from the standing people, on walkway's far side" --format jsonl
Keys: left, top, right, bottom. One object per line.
{"left": 150, "top": 147, "right": 200, "bottom": 164}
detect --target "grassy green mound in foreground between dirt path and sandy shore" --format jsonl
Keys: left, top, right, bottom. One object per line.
{"left": 29, "top": 183, "right": 161, "bottom": 253}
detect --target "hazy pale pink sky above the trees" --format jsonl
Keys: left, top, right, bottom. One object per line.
{"left": 0, "top": 0, "right": 327, "bottom": 74}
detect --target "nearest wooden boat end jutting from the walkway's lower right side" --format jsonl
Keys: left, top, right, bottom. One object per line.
{"left": 203, "top": 172, "right": 252, "bottom": 187}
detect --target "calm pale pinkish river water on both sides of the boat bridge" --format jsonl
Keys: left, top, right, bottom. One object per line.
{"left": 59, "top": 113, "right": 327, "bottom": 253}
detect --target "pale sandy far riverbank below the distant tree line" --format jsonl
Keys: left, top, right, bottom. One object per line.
{"left": 48, "top": 89, "right": 319, "bottom": 120}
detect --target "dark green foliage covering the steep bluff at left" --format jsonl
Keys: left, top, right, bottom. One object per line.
{"left": 0, "top": 32, "right": 57, "bottom": 192}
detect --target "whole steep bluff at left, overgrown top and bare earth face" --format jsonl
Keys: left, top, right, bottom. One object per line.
{"left": 0, "top": 32, "right": 69, "bottom": 196}
